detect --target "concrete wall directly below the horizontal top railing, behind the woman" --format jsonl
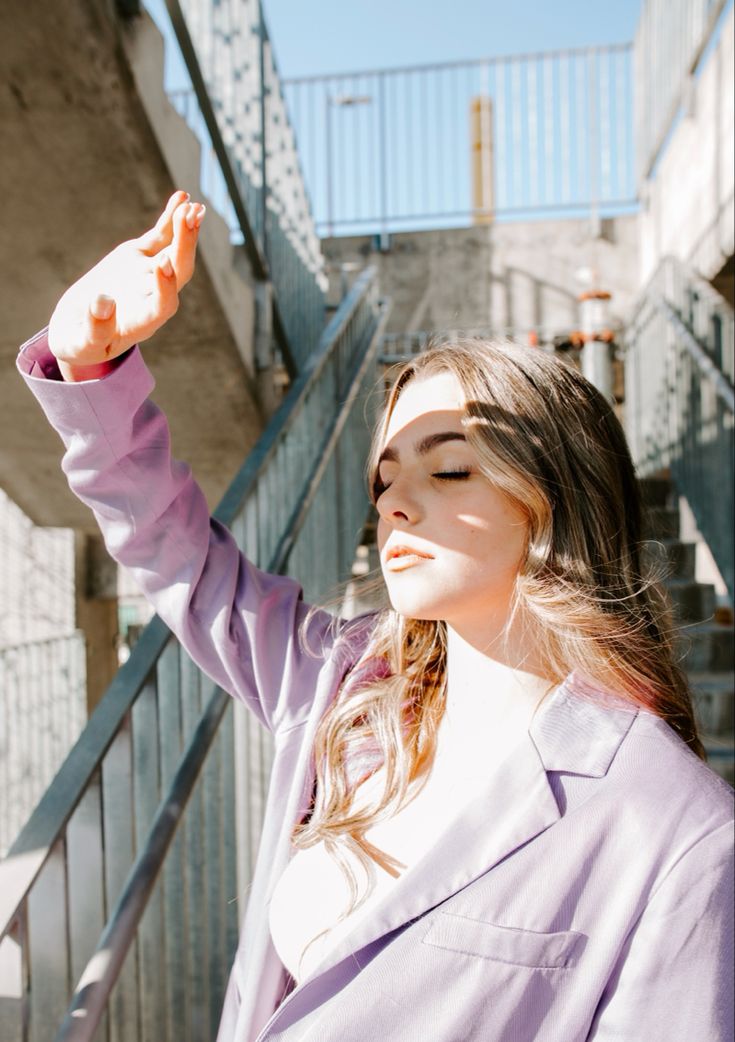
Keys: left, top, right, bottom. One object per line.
{"left": 323, "top": 216, "right": 639, "bottom": 336}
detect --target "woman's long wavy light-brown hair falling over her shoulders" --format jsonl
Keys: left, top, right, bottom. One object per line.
{"left": 293, "top": 338, "right": 705, "bottom": 966}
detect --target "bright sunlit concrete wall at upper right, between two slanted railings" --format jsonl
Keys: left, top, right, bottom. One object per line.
{"left": 640, "top": 7, "right": 735, "bottom": 292}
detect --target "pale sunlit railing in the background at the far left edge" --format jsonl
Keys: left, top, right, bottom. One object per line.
{"left": 0, "top": 630, "right": 87, "bottom": 858}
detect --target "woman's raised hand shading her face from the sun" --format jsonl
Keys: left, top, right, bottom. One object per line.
{"left": 48, "top": 192, "right": 204, "bottom": 380}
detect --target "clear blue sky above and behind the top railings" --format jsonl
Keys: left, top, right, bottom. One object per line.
{"left": 145, "top": 0, "right": 641, "bottom": 233}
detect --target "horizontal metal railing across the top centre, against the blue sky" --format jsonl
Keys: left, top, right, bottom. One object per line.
{"left": 284, "top": 44, "right": 636, "bottom": 235}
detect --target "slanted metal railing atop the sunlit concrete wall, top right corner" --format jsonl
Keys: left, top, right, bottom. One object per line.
{"left": 634, "top": 0, "right": 729, "bottom": 184}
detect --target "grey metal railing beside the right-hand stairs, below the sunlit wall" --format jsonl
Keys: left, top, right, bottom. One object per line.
{"left": 626, "top": 257, "right": 735, "bottom": 598}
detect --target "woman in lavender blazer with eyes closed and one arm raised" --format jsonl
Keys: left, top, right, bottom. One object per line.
{"left": 19, "top": 193, "right": 733, "bottom": 1042}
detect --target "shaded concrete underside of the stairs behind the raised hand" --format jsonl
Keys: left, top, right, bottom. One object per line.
{"left": 0, "top": 0, "right": 263, "bottom": 530}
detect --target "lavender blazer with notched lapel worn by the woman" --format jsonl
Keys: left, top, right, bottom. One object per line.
{"left": 19, "top": 333, "right": 733, "bottom": 1042}
